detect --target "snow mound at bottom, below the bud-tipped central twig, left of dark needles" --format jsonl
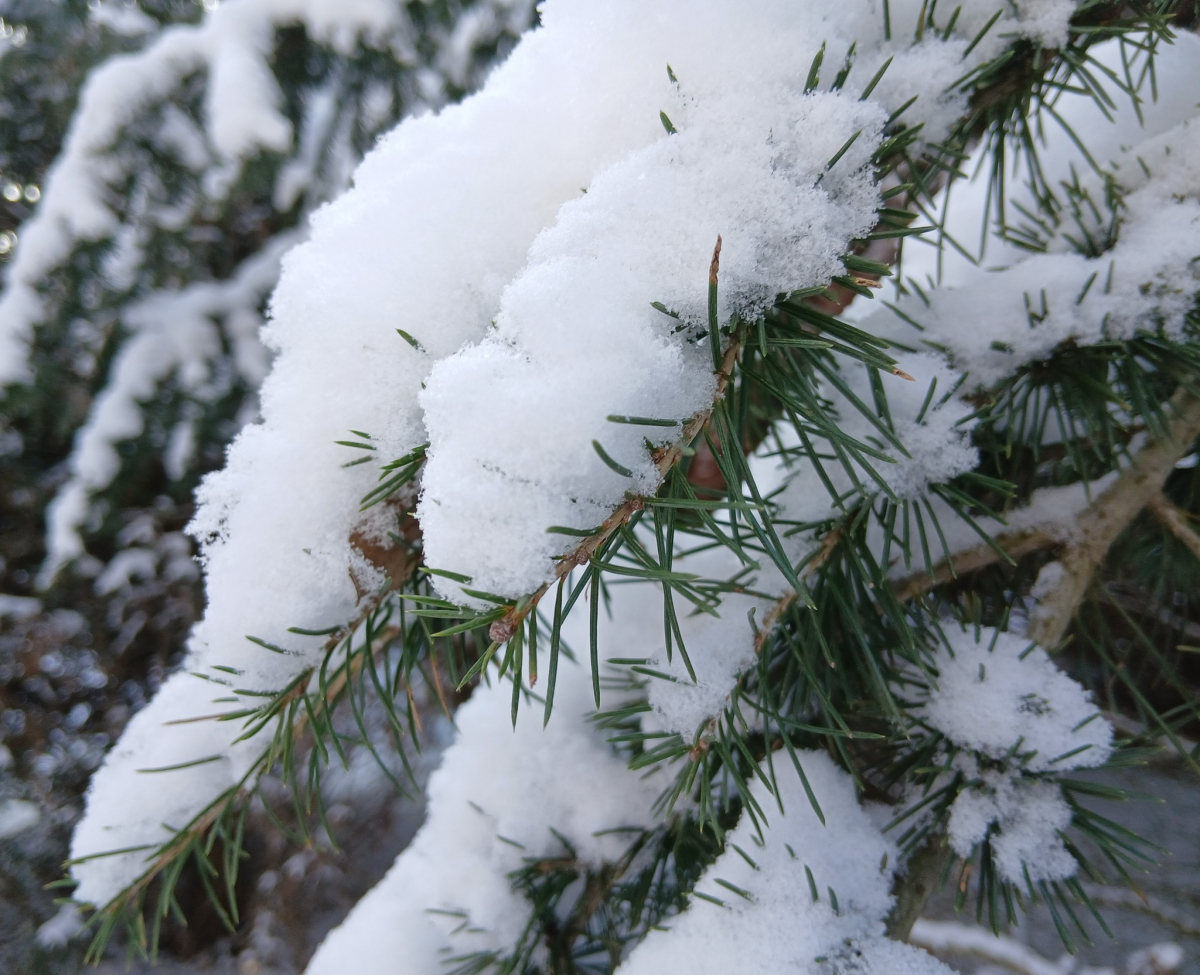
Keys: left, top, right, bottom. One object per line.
{"left": 298, "top": 659, "right": 662, "bottom": 975}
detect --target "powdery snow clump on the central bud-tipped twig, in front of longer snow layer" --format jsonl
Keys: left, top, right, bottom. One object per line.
{"left": 418, "top": 79, "right": 884, "bottom": 598}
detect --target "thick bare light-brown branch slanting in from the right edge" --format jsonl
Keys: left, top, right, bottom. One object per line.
{"left": 1030, "top": 389, "right": 1200, "bottom": 650}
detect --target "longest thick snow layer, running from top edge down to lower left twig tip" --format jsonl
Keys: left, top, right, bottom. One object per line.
{"left": 74, "top": 2, "right": 835, "bottom": 903}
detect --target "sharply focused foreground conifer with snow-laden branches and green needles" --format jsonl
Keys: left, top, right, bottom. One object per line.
{"left": 18, "top": 0, "right": 1200, "bottom": 975}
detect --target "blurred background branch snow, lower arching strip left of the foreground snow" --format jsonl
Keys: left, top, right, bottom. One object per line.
{"left": 41, "top": 234, "right": 296, "bottom": 585}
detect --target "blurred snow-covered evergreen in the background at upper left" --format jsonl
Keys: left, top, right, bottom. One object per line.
{"left": 0, "top": 0, "right": 533, "bottom": 792}
